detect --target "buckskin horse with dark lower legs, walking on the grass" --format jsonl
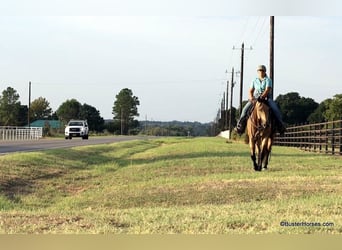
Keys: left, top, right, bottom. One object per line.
{"left": 247, "top": 98, "right": 275, "bottom": 171}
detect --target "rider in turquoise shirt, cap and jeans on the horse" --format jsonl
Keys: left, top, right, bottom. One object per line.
{"left": 236, "top": 65, "right": 286, "bottom": 135}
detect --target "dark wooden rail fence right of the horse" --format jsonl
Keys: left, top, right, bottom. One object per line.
{"left": 274, "top": 120, "right": 342, "bottom": 155}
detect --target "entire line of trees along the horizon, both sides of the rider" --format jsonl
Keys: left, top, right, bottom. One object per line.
{"left": 0, "top": 87, "right": 342, "bottom": 136}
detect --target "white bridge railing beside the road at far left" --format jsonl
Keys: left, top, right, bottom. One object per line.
{"left": 0, "top": 126, "right": 43, "bottom": 141}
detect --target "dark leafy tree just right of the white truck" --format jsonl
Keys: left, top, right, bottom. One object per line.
{"left": 80, "top": 103, "right": 104, "bottom": 132}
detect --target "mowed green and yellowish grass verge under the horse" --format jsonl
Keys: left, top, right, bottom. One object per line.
{"left": 0, "top": 138, "right": 342, "bottom": 234}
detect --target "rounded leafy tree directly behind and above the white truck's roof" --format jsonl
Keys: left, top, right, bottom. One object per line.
{"left": 56, "top": 99, "right": 82, "bottom": 123}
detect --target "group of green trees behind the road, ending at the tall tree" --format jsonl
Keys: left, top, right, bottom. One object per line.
{"left": 0, "top": 87, "right": 139, "bottom": 134}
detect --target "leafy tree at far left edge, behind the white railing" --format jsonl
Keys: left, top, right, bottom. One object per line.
{"left": 0, "top": 87, "right": 21, "bottom": 126}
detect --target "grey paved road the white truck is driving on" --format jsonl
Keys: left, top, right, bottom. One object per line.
{"left": 0, "top": 136, "right": 153, "bottom": 154}
